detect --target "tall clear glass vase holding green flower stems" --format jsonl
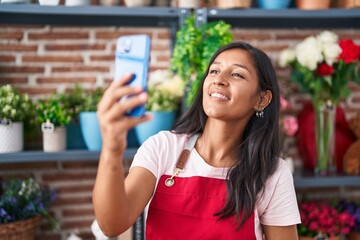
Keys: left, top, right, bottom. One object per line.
{"left": 313, "top": 99, "right": 336, "bottom": 175}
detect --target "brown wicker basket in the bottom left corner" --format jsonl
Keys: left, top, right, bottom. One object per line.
{"left": 0, "top": 216, "right": 41, "bottom": 240}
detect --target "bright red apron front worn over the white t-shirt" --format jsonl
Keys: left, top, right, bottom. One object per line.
{"left": 146, "top": 175, "right": 256, "bottom": 240}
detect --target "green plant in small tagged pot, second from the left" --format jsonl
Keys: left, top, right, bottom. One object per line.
{"left": 36, "top": 95, "right": 73, "bottom": 127}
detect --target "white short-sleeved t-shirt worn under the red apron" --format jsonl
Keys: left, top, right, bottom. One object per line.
{"left": 131, "top": 131, "right": 301, "bottom": 239}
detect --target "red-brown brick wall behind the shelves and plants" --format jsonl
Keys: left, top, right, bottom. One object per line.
{"left": 0, "top": 25, "right": 360, "bottom": 239}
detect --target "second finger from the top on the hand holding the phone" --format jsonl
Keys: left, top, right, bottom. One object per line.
{"left": 98, "top": 86, "right": 143, "bottom": 114}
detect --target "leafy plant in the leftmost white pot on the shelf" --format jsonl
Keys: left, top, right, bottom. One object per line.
{"left": 0, "top": 85, "right": 33, "bottom": 122}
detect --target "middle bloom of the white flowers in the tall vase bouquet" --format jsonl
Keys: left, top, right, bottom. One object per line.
{"left": 295, "top": 36, "right": 324, "bottom": 71}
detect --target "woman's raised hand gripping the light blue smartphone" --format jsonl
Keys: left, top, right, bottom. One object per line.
{"left": 97, "top": 74, "right": 151, "bottom": 153}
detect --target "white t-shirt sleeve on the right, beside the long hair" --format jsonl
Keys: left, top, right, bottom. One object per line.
{"left": 259, "top": 160, "right": 301, "bottom": 226}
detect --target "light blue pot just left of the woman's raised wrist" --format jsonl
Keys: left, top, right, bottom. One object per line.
{"left": 80, "top": 112, "right": 102, "bottom": 151}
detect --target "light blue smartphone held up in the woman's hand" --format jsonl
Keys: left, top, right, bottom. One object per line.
{"left": 114, "top": 34, "right": 150, "bottom": 117}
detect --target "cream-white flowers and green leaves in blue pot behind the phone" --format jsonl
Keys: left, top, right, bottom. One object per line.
{"left": 146, "top": 70, "right": 183, "bottom": 112}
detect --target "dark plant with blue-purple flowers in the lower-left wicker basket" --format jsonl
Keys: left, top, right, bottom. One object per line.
{"left": 0, "top": 178, "right": 56, "bottom": 228}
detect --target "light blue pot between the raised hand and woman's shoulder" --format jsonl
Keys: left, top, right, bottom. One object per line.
{"left": 135, "top": 112, "right": 176, "bottom": 144}
